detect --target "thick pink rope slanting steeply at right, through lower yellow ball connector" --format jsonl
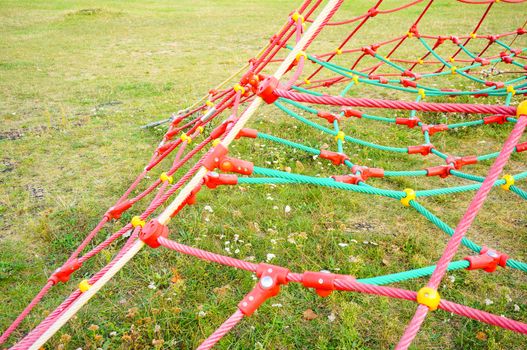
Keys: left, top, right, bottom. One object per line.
{"left": 396, "top": 116, "right": 527, "bottom": 349}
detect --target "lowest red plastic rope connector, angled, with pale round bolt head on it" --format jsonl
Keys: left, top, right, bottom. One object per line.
{"left": 238, "top": 263, "right": 289, "bottom": 316}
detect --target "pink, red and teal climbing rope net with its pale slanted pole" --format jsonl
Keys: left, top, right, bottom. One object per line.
{"left": 0, "top": 0, "right": 527, "bottom": 349}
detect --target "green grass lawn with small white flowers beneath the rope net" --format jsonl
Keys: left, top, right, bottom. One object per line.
{"left": 0, "top": 0, "right": 527, "bottom": 349}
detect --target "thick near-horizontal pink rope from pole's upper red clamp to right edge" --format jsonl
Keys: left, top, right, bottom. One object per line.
{"left": 275, "top": 89, "right": 516, "bottom": 115}
